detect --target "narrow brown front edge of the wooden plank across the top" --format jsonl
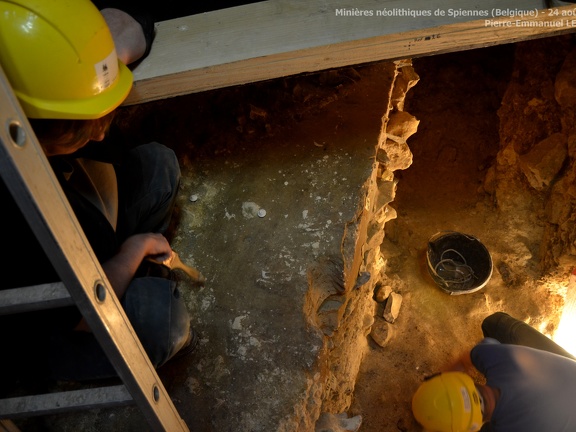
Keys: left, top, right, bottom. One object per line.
{"left": 124, "top": 7, "right": 576, "bottom": 105}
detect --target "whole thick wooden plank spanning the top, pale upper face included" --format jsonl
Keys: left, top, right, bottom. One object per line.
{"left": 126, "top": 0, "right": 576, "bottom": 105}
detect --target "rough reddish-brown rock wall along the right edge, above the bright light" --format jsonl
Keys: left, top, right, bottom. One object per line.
{"left": 484, "top": 36, "right": 576, "bottom": 274}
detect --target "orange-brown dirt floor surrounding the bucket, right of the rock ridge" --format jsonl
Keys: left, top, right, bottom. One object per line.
{"left": 349, "top": 41, "right": 559, "bottom": 432}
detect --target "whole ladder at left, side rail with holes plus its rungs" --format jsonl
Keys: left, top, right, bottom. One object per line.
{"left": 0, "top": 62, "right": 188, "bottom": 432}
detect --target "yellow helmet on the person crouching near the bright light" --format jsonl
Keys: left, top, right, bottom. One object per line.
{"left": 412, "top": 372, "right": 482, "bottom": 432}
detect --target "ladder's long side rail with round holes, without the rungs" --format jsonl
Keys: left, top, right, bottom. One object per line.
{"left": 0, "top": 68, "right": 188, "bottom": 431}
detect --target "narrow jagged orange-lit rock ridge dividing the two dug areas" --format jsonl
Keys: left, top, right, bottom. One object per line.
{"left": 307, "top": 61, "right": 419, "bottom": 413}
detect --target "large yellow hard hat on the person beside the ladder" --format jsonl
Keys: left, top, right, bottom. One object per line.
{"left": 0, "top": 0, "right": 133, "bottom": 120}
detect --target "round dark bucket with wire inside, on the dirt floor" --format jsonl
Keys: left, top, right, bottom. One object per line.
{"left": 426, "top": 231, "right": 492, "bottom": 295}
